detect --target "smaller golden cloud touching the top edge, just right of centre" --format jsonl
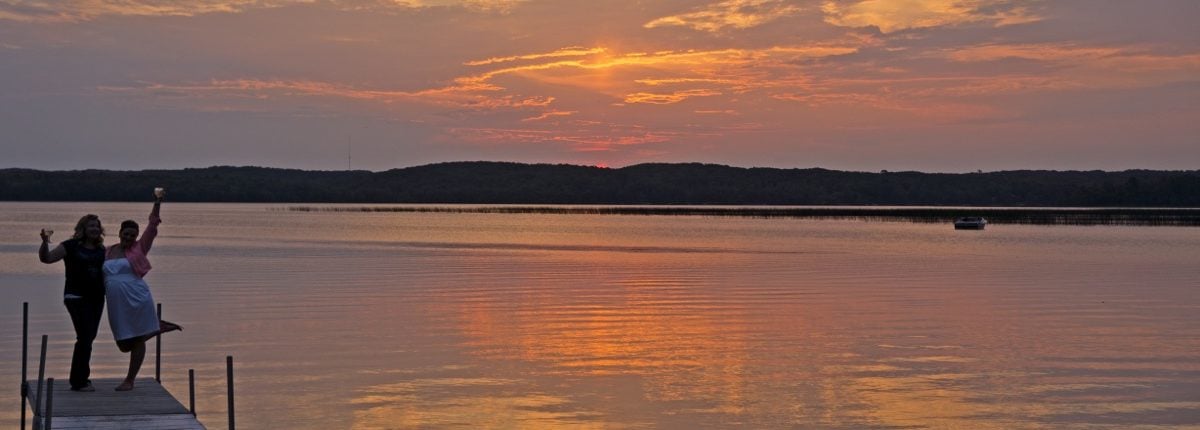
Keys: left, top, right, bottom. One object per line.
{"left": 643, "top": 0, "right": 800, "bottom": 32}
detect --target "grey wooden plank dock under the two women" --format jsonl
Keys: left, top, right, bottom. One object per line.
{"left": 28, "top": 378, "right": 204, "bottom": 430}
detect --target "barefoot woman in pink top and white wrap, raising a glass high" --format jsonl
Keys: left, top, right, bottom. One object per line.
{"left": 103, "top": 191, "right": 184, "bottom": 392}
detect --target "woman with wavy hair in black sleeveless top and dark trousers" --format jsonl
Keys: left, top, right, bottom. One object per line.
{"left": 37, "top": 214, "right": 104, "bottom": 392}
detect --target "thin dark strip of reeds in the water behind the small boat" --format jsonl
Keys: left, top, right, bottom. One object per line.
{"left": 271, "top": 205, "right": 1200, "bottom": 227}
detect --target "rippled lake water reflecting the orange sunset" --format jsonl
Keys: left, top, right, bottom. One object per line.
{"left": 0, "top": 202, "right": 1200, "bottom": 429}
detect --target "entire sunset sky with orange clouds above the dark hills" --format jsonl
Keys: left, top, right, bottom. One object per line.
{"left": 0, "top": 0, "right": 1200, "bottom": 172}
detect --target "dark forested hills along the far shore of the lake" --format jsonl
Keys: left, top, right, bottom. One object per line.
{"left": 0, "top": 162, "right": 1200, "bottom": 207}
